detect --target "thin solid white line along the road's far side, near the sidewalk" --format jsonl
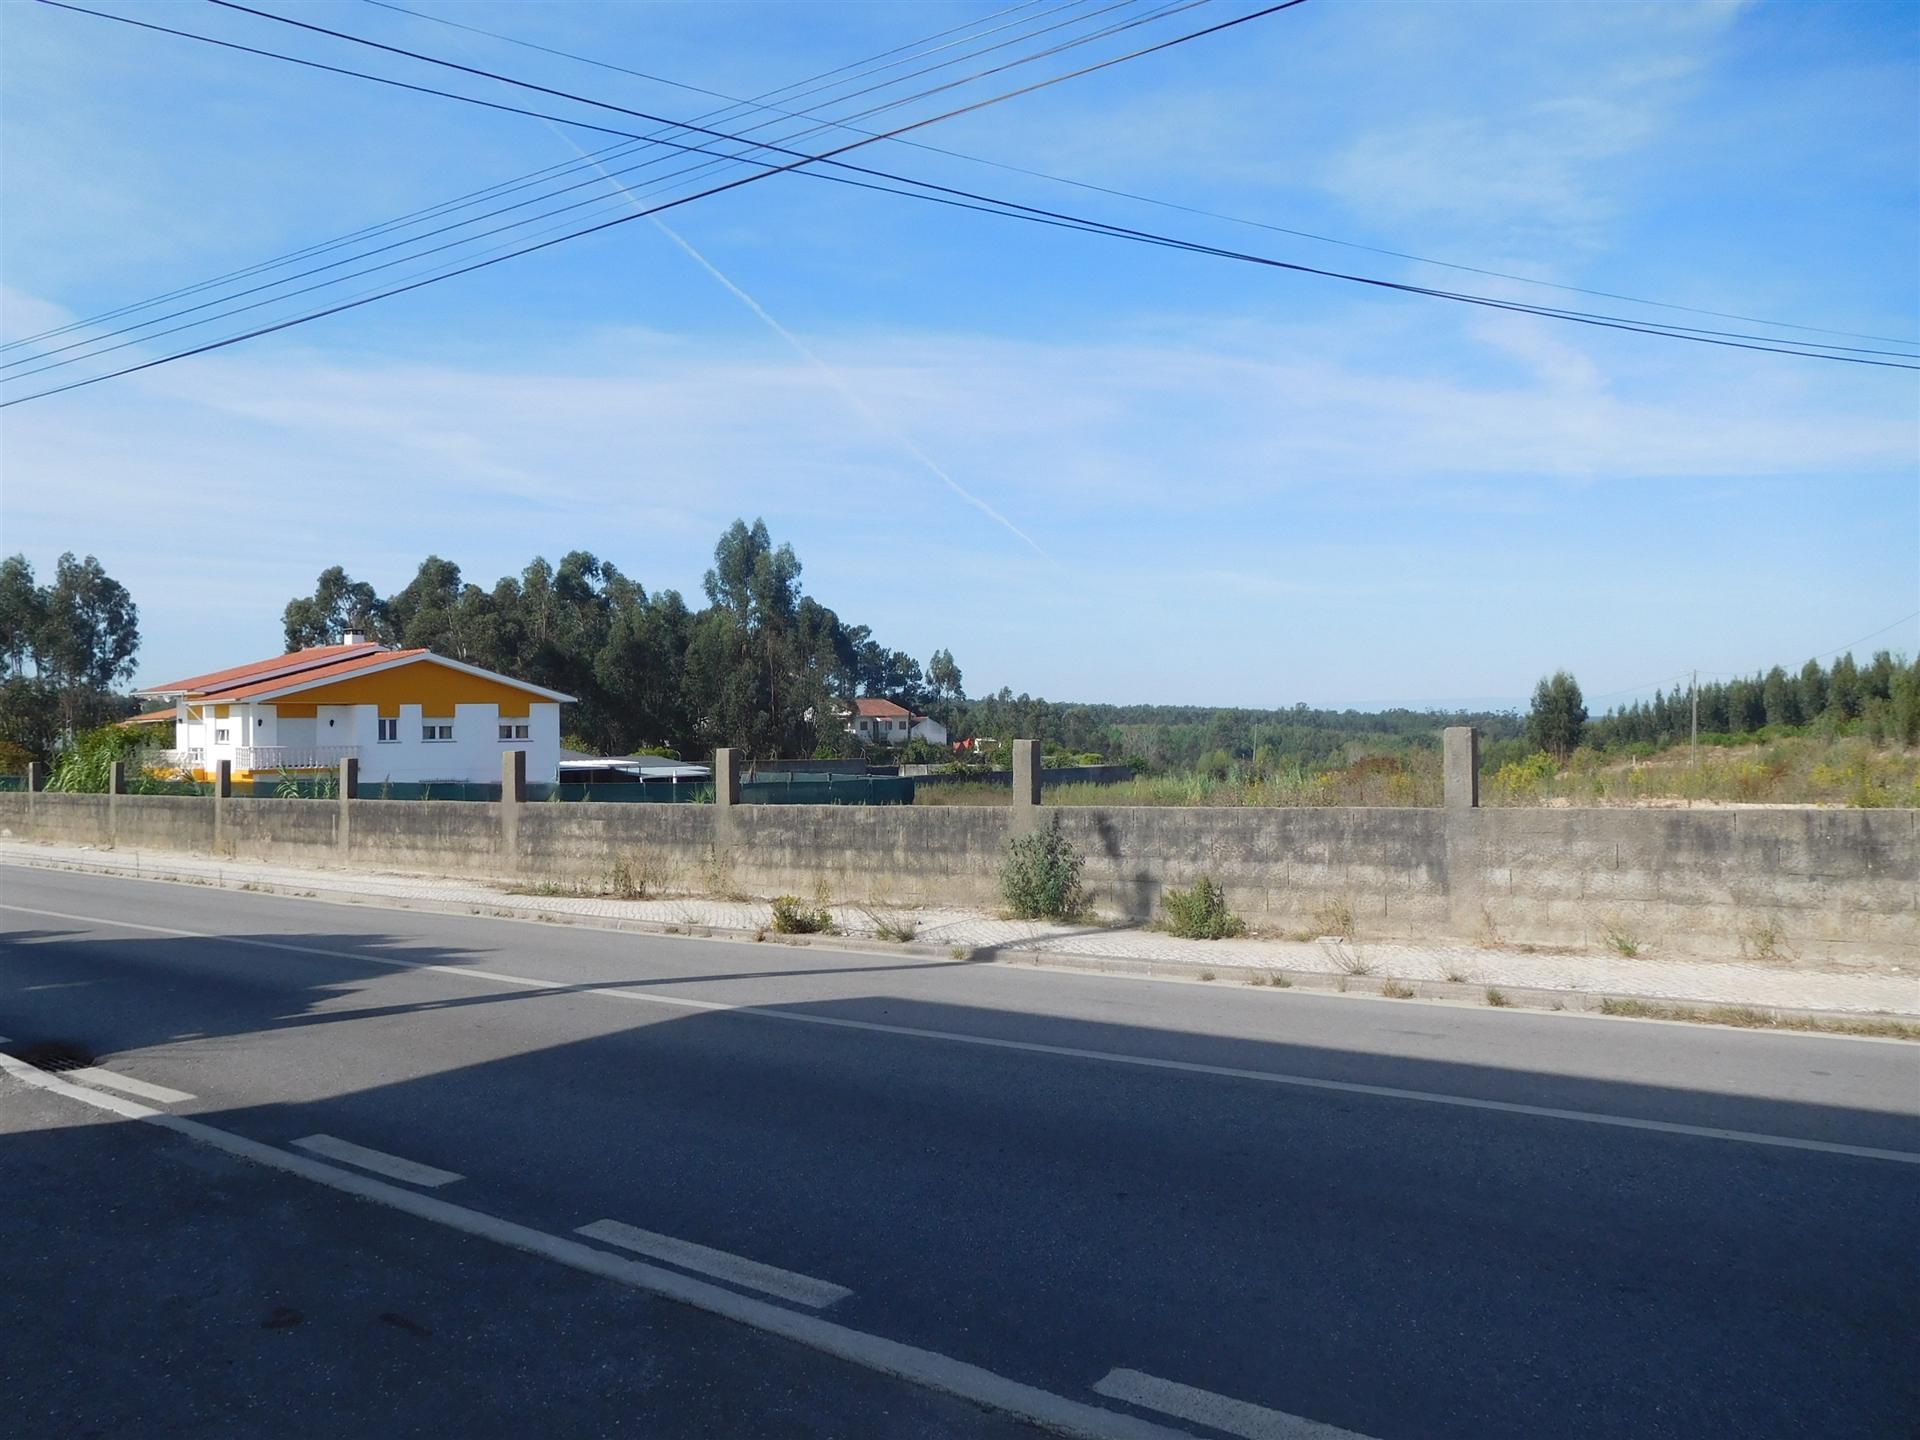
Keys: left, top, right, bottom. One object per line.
{"left": 0, "top": 904, "right": 1920, "bottom": 1165}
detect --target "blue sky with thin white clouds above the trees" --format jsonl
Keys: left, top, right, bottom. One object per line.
{"left": 0, "top": 0, "right": 1920, "bottom": 708}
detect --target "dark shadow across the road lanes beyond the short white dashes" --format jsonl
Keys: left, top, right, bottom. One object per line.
{"left": 0, "top": 913, "right": 1920, "bottom": 1440}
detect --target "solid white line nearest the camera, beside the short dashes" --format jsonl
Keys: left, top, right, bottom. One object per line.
{"left": 0, "top": 1054, "right": 1192, "bottom": 1440}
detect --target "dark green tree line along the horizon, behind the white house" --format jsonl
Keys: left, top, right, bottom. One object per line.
{"left": 0, "top": 520, "right": 1920, "bottom": 778}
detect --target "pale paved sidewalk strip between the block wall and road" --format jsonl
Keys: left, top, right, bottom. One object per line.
{"left": 0, "top": 841, "right": 1920, "bottom": 1016}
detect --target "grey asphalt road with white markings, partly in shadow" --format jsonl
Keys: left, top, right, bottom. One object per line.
{"left": 0, "top": 868, "right": 1920, "bottom": 1440}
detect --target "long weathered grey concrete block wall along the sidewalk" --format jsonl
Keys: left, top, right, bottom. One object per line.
{"left": 0, "top": 791, "right": 1920, "bottom": 966}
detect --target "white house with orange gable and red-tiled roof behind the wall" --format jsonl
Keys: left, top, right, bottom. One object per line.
{"left": 136, "top": 636, "right": 572, "bottom": 785}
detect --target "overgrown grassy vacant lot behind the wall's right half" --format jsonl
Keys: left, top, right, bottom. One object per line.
{"left": 916, "top": 735, "right": 1920, "bottom": 808}
